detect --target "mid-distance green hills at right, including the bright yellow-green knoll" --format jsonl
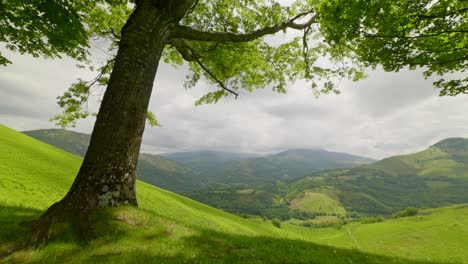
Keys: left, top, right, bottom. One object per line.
{"left": 190, "top": 138, "right": 468, "bottom": 219}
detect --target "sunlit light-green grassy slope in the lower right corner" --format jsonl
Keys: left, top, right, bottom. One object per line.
{"left": 284, "top": 205, "right": 468, "bottom": 263}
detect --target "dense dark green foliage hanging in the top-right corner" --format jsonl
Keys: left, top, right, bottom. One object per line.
{"left": 318, "top": 0, "right": 468, "bottom": 96}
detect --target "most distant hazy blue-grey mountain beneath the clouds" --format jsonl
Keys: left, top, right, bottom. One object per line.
{"left": 164, "top": 149, "right": 373, "bottom": 185}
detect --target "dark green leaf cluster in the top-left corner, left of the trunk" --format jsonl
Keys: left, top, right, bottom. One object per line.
{"left": 0, "top": 0, "right": 94, "bottom": 65}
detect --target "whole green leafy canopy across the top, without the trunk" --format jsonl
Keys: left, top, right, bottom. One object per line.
{"left": 0, "top": 0, "right": 468, "bottom": 126}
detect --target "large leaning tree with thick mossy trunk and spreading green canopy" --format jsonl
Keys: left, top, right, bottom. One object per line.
{"left": 0, "top": 0, "right": 467, "bottom": 243}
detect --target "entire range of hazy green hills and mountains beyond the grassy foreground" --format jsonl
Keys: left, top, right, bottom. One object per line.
{"left": 24, "top": 129, "right": 468, "bottom": 218}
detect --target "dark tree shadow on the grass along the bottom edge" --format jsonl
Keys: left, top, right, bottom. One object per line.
{"left": 84, "top": 231, "right": 458, "bottom": 264}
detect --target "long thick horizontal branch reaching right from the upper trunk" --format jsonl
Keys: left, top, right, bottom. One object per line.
{"left": 170, "top": 10, "right": 317, "bottom": 43}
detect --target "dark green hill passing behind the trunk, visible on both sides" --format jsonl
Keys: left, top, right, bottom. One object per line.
{"left": 23, "top": 129, "right": 207, "bottom": 193}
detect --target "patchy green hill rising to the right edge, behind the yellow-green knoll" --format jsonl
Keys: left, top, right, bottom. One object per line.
{"left": 288, "top": 138, "right": 468, "bottom": 215}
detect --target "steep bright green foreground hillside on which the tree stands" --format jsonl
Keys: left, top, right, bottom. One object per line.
{"left": 0, "top": 126, "right": 462, "bottom": 264}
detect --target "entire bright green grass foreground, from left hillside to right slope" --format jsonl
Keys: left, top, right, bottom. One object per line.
{"left": 0, "top": 126, "right": 468, "bottom": 263}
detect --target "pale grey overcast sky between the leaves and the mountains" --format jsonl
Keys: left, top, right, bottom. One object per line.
{"left": 0, "top": 45, "right": 468, "bottom": 158}
